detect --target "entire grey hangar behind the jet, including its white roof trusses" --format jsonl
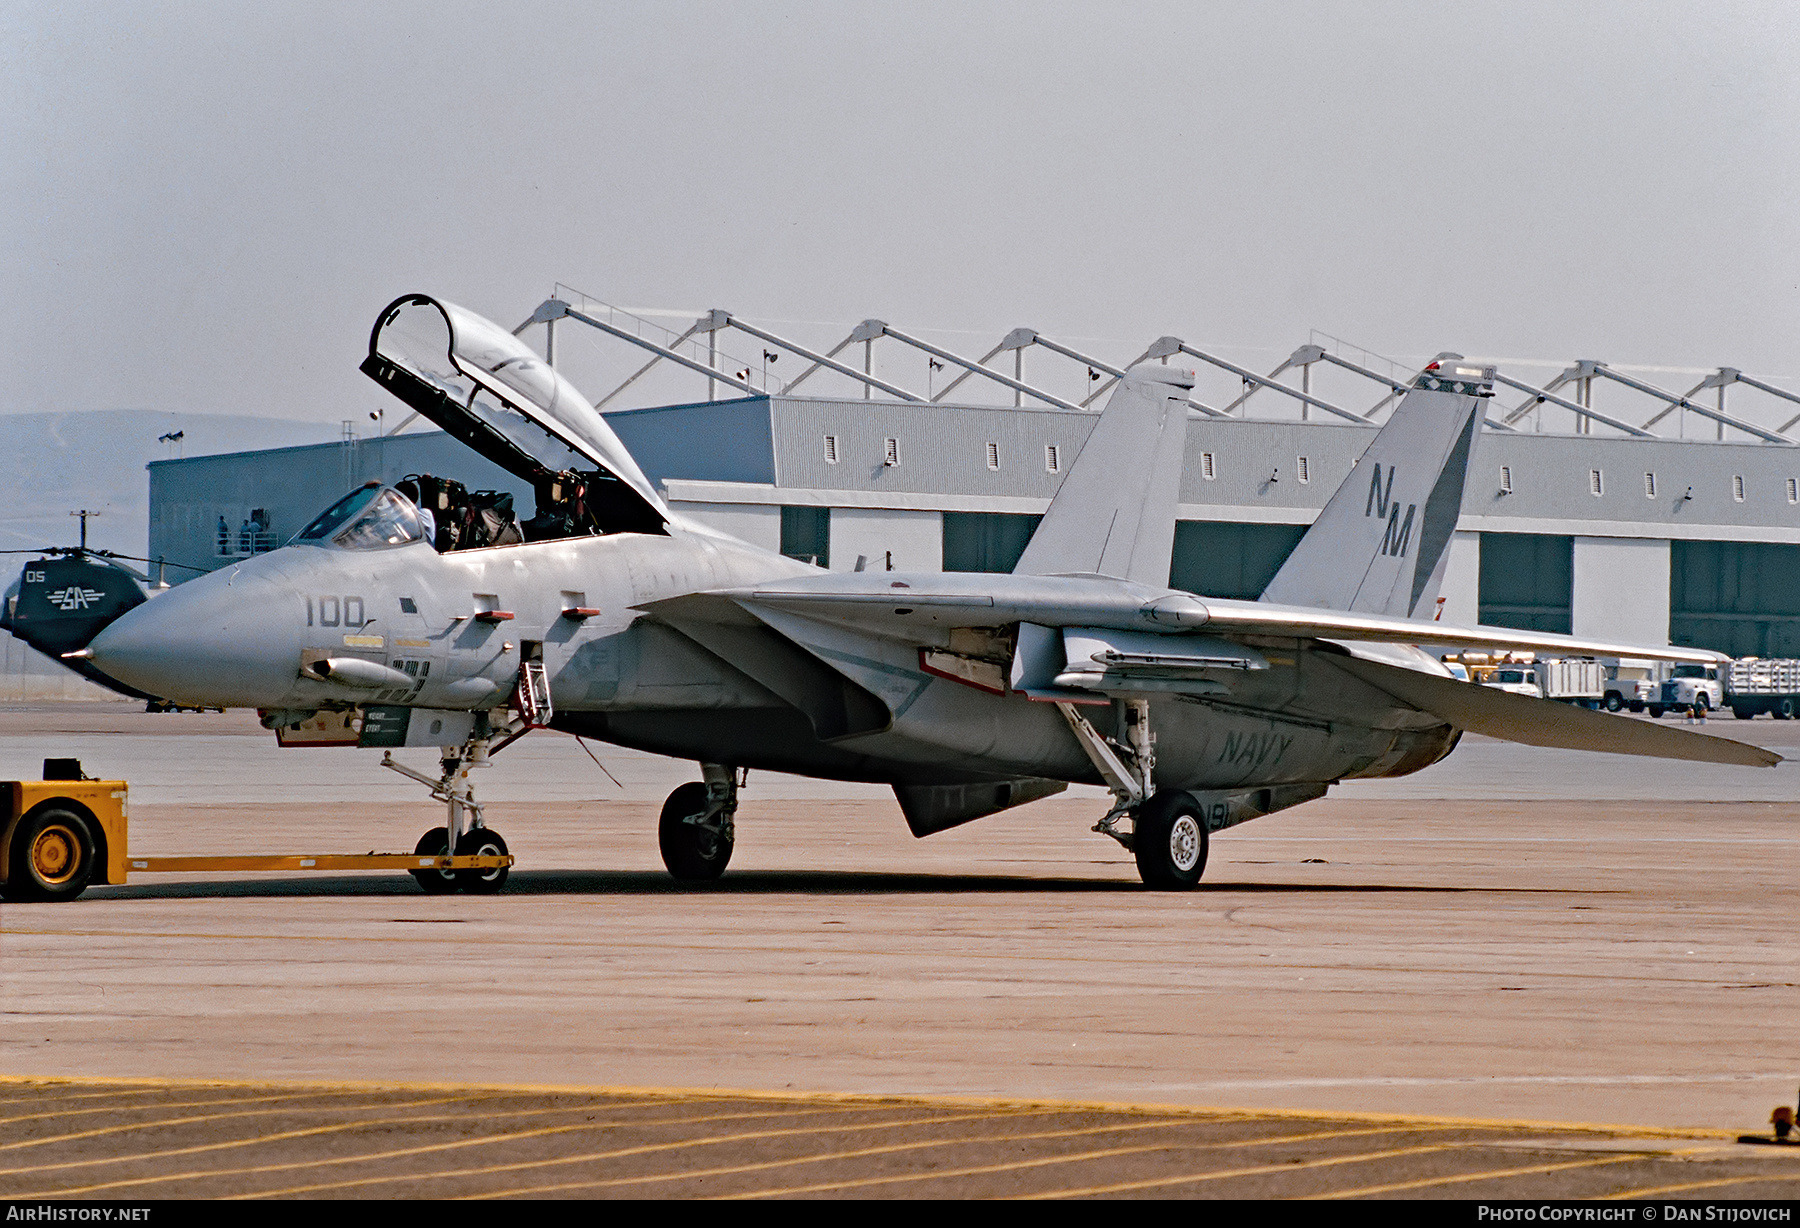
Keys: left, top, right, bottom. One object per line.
{"left": 112, "top": 284, "right": 1800, "bottom": 657}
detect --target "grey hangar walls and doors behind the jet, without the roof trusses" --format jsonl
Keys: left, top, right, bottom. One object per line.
{"left": 149, "top": 393, "right": 1800, "bottom": 655}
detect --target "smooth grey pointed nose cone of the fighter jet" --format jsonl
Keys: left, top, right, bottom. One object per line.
{"left": 88, "top": 565, "right": 301, "bottom": 708}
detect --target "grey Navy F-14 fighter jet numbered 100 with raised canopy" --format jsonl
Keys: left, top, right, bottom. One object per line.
{"left": 49, "top": 295, "right": 1778, "bottom": 889}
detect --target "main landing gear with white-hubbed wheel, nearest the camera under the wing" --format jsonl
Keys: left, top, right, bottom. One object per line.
{"left": 1057, "top": 699, "right": 1208, "bottom": 891}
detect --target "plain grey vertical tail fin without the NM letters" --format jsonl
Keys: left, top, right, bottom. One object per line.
{"left": 1013, "top": 362, "right": 1193, "bottom": 589}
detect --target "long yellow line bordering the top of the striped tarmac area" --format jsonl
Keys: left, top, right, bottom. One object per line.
{"left": 0, "top": 1075, "right": 1741, "bottom": 1140}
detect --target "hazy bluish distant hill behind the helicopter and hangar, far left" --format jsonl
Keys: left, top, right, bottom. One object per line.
{"left": 0, "top": 409, "right": 338, "bottom": 558}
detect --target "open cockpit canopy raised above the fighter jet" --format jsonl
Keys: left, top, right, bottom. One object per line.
{"left": 362, "top": 293, "right": 668, "bottom": 533}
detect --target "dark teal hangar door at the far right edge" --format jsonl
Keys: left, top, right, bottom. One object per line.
{"left": 1669, "top": 542, "right": 1800, "bottom": 657}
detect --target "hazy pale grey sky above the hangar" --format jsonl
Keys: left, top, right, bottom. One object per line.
{"left": 0, "top": 0, "right": 1800, "bottom": 421}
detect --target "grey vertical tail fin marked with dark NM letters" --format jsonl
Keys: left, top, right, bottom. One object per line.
{"left": 1262, "top": 355, "right": 1494, "bottom": 618}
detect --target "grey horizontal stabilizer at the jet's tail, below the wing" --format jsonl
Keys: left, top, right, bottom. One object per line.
{"left": 1332, "top": 657, "right": 1782, "bottom": 767}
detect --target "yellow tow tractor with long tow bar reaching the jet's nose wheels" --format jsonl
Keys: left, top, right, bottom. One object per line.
{"left": 0, "top": 758, "right": 513, "bottom": 900}
